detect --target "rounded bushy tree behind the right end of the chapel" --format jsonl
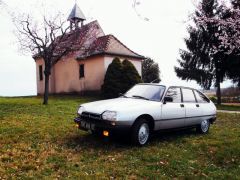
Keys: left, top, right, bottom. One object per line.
{"left": 142, "top": 58, "right": 161, "bottom": 83}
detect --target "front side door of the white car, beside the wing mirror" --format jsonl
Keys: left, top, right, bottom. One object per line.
{"left": 159, "top": 87, "right": 185, "bottom": 129}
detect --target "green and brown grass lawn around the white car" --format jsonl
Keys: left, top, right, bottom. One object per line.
{"left": 0, "top": 96, "right": 240, "bottom": 179}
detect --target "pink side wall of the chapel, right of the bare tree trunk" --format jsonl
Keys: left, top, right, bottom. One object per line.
{"left": 53, "top": 57, "right": 104, "bottom": 93}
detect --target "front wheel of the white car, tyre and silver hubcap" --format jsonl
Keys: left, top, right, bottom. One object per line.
{"left": 131, "top": 119, "right": 150, "bottom": 146}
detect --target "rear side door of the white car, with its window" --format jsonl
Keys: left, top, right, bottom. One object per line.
{"left": 182, "top": 88, "right": 202, "bottom": 126}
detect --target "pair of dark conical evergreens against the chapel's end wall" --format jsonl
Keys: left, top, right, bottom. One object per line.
{"left": 102, "top": 58, "right": 142, "bottom": 98}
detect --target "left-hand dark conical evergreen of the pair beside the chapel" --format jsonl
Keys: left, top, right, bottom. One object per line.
{"left": 102, "top": 58, "right": 123, "bottom": 98}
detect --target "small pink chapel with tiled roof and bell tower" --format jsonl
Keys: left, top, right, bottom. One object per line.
{"left": 34, "top": 4, "right": 144, "bottom": 94}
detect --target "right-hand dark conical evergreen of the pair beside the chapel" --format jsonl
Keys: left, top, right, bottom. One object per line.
{"left": 121, "top": 59, "right": 142, "bottom": 93}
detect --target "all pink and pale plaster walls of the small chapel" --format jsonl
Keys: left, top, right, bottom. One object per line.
{"left": 36, "top": 56, "right": 141, "bottom": 94}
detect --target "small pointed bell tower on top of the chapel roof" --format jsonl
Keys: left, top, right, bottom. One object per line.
{"left": 68, "top": 3, "right": 86, "bottom": 30}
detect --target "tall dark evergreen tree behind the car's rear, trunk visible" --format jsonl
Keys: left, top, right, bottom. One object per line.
{"left": 175, "top": 0, "right": 227, "bottom": 104}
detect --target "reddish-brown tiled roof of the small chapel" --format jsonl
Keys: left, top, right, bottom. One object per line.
{"left": 33, "top": 21, "right": 144, "bottom": 59}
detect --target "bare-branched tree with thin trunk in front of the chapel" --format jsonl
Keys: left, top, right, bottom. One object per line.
{"left": 13, "top": 14, "right": 76, "bottom": 104}
